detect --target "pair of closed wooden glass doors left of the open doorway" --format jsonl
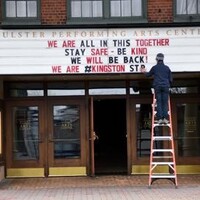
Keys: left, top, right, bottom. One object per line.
{"left": 6, "top": 99, "right": 86, "bottom": 177}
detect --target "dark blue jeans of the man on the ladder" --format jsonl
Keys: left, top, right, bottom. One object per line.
{"left": 154, "top": 86, "right": 169, "bottom": 119}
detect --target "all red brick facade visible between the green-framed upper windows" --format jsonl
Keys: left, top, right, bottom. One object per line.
{"left": 0, "top": 0, "right": 173, "bottom": 25}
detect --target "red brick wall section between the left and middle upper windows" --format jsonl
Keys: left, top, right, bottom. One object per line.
{"left": 41, "top": 0, "right": 66, "bottom": 25}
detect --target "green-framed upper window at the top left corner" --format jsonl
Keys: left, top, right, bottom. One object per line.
{"left": 3, "top": 0, "right": 40, "bottom": 24}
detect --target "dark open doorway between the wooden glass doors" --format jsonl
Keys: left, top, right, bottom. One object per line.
{"left": 93, "top": 99, "right": 127, "bottom": 175}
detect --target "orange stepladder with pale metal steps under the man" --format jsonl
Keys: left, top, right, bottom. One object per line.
{"left": 149, "top": 93, "right": 178, "bottom": 188}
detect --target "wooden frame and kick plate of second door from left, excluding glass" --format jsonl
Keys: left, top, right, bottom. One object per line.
{"left": 46, "top": 97, "right": 87, "bottom": 176}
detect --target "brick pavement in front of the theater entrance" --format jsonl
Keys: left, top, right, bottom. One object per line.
{"left": 0, "top": 175, "right": 200, "bottom": 200}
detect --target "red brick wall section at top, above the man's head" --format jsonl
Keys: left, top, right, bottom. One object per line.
{"left": 147, "top": 0, "right": 173, "bottom": 23}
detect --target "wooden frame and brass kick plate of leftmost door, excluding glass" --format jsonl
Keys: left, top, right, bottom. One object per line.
{"left": 4, "top": 100, "right": 46, "bottom": 177}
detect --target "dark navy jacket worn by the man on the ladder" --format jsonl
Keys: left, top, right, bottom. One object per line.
{"left": 146, "top": 61, "right": 172, "bottom": 88}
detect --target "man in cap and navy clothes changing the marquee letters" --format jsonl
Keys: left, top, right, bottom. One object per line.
{"left": 140, "top": 53, "right": 172, "bottom": 124}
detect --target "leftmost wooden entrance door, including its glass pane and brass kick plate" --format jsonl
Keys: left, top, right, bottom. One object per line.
{"left": 6, "top": 102, "right": 45, "bottom": 177}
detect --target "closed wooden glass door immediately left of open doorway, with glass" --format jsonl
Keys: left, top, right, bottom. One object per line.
{"left": 48, "top": 101, "right": 86, "bottom": 176}
